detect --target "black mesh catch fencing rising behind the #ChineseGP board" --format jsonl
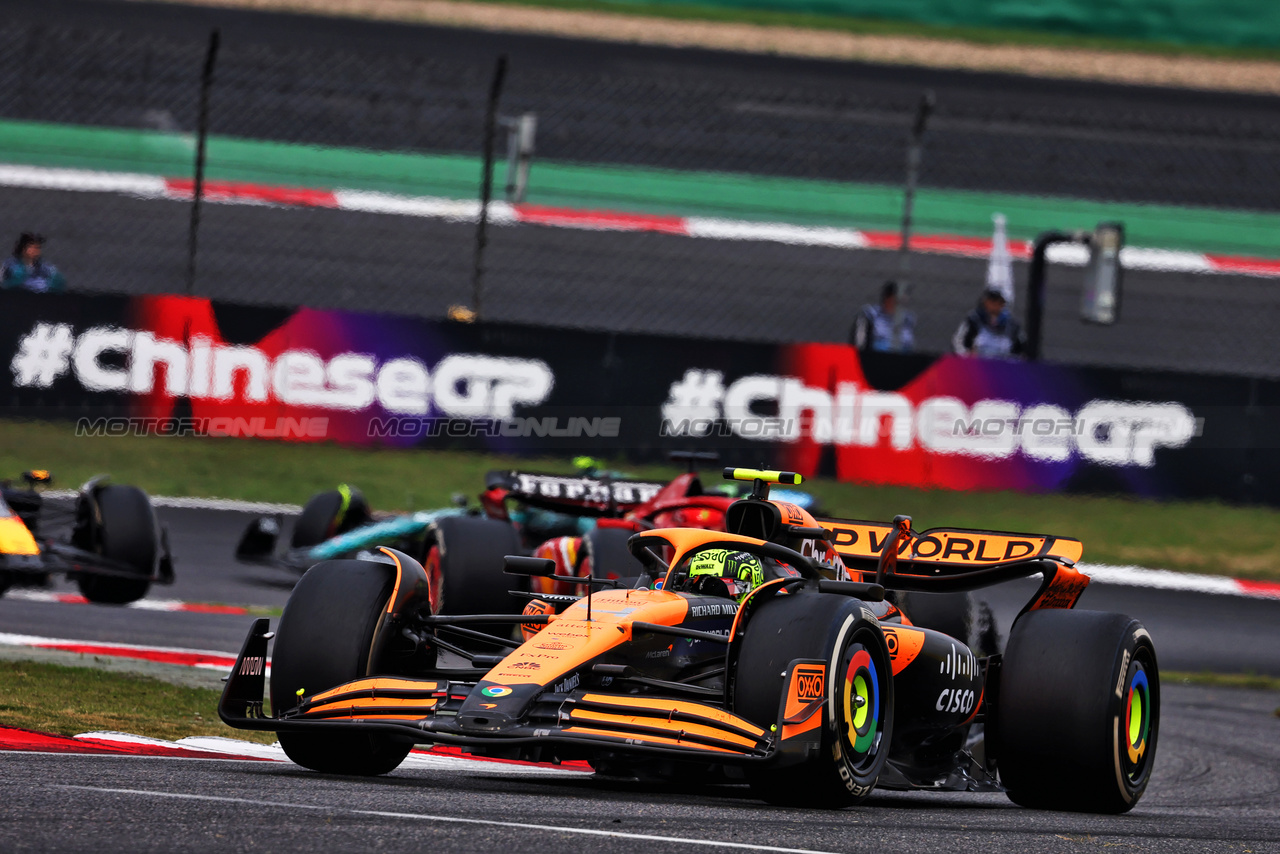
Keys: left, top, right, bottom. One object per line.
{"left": 0, "top": 8, "right": 1280, "bottom": 376}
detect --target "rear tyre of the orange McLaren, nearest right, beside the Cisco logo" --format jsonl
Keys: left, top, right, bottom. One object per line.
{"left": 995, "top": 611, "right": 1160, "bottom": 813}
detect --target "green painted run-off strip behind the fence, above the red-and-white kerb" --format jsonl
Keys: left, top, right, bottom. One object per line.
{"left": 10, "top": 122, "right": 1280, "bottom": 257}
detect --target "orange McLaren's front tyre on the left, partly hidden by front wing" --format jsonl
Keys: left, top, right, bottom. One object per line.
{"left": 271, "top": 561, "right": 413, "bottom": 777}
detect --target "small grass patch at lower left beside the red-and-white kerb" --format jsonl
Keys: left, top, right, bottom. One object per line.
{"left": 0, "top": 661, "right": 275, "bottom": 744}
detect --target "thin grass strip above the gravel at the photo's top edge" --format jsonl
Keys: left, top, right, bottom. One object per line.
{"left": 453, "top": 0, "right": 1280, "bottom": 60}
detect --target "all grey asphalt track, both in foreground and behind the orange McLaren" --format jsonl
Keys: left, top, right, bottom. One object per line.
{"left": 0, "top": 508, "right": 1280, "bottom": 854}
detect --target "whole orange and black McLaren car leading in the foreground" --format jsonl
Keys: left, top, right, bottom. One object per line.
{"left": 219, "top": 470, "right": 1160, "bottom": 813}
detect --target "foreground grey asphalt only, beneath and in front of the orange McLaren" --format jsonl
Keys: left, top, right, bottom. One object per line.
{"left": 0, "top": 684, "right": 1280, "bottom": 854}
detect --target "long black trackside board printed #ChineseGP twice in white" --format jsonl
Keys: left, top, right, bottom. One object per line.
{"left": 0, "top": 294, "right": 1280, "bottom": 503}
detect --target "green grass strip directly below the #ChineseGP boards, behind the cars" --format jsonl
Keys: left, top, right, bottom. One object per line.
{"left": 0, "top": 421, "right": 1280, "bottom": 580}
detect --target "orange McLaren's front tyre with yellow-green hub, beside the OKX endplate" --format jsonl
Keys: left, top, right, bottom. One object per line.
{"left": 733, "top": 592, "right": 893, "bottom": 809}
